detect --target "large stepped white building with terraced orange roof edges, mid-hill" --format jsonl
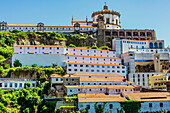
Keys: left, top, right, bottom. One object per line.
{"left": 12, "top": 45, "right": 126, "bottom": 78}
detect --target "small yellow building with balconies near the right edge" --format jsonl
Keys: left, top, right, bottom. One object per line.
{"left": 149, "top": 74, "right": 168, "bottom": 91}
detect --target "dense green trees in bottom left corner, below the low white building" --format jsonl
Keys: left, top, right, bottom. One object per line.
{"left": 0, "top": 82, "right": 56, "bottom": 113}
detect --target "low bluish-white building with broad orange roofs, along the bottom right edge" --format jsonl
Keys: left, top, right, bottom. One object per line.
{"left": 78, "top": 92, "right": 170, "bottom": 113}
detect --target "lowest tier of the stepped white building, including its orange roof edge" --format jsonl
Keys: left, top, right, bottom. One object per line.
{"left": 67, "top": 62, "right": 126, "bottom": 78}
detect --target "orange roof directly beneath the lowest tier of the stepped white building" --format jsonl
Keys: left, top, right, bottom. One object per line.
{"left": 73, "top": 72, "right": 123, "bottom": 77}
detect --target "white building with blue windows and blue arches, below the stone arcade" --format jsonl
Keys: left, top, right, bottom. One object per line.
{"left": 112, "top": 38, "right": 164, "bottom": 57}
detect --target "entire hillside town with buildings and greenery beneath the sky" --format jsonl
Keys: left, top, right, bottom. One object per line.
{"left": 0, "top": 4, "right": 170, "bottom": 113}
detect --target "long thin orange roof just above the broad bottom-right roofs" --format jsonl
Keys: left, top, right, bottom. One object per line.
{"left": 65, "top": 85, "right": 135, "bottom": 89}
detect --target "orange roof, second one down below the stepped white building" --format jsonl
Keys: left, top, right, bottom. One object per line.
{"left": 80, "top": 77, "right": 123, "bottom": 82}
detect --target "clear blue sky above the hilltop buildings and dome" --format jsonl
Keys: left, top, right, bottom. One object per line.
{"left": 0, "top": 0, "right": 170, "bottom": 46}
